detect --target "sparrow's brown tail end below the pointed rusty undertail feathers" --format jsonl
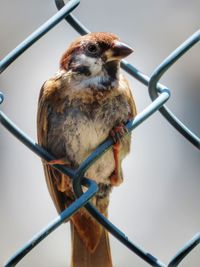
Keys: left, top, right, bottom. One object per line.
{"left": 71, "top": 222, "right": 113, "bottom": 267}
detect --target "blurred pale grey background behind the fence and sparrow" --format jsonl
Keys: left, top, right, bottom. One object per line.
{"left": 0, "top": 0, "right": 200, "bottom": 267}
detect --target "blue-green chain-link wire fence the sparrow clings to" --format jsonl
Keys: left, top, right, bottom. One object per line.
{"left": 0, "top": 0, "right": 200, "bottom": 267}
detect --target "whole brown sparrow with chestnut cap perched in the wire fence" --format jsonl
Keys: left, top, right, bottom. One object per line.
{"left": 37, "top": 32, "right": 137, "bottom": 267}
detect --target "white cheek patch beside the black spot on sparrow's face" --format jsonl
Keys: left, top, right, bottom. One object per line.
{"left": 77, "top": 54, "right": 103, "bottom": 76}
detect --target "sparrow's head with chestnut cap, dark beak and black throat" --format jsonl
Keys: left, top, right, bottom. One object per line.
{"left": 60, "top": 32, "right": 133, "bottom": 88}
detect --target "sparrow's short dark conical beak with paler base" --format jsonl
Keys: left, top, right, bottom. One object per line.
{"left": 105, "top": 41, "right": 133, "bottom": 62}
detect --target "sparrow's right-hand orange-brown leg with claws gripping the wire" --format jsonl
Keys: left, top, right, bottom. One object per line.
{"left": 110, "top": 123, "right": 128, "bottom": 186}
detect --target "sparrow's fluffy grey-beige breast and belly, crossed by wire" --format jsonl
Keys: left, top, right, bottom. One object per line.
{"left": 58, "top": 95, "right": 130, "bottom": 183}
